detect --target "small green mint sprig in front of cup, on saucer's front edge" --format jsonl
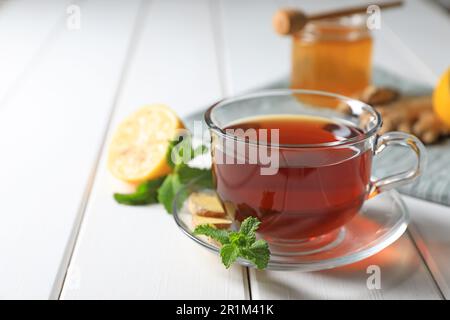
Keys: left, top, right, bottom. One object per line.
{"left": 194, "top": 217, "right": 270, "bottom": 269}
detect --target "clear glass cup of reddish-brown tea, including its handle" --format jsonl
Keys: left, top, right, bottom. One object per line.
{"left": 205, "top": 89, "right": 425, "bottom": 250}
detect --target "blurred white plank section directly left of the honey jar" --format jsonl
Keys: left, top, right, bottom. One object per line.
{"left": 218, "top": 0, "right": 291, "bottom": 95}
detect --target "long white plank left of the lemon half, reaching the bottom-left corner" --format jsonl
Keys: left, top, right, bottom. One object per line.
{"left": 0, "top": 0, "right": 139, "bottom": 299}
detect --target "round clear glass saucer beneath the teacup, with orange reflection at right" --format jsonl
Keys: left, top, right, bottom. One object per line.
{"left": 173, "top": 190, "right": 409, "bottom": 271}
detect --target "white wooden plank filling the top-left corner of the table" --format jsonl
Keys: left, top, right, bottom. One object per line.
{"left": 0, "top": 0, "right": 69, "bottom": 104}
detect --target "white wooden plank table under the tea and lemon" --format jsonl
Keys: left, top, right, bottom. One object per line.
{"left": 0, "top": 0, "right": 450, "bottom": 299}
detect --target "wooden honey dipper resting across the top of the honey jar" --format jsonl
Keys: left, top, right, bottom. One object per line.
{"left": 272, "top": 1, "right": 403, "bottom": 35}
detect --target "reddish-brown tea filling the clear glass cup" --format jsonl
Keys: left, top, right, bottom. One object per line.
{"left": 213, "top": 116, "right": 372, "bottom": 241}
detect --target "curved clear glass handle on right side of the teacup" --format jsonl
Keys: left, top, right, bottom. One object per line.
{"left": 369, "top": 132, "right": 426, "bottom": 198}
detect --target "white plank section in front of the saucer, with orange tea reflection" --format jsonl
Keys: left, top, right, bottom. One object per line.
{"left": 250, "top": 236, "right": 441, "bottom": 300}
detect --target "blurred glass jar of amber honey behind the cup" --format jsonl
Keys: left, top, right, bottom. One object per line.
{"left": 291, "top": 15, "right": 372, "bottom": 103}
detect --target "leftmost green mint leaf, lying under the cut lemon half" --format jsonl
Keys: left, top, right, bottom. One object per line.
{"left": 114, "top": 177, "right": 164, "bottom": 206}
